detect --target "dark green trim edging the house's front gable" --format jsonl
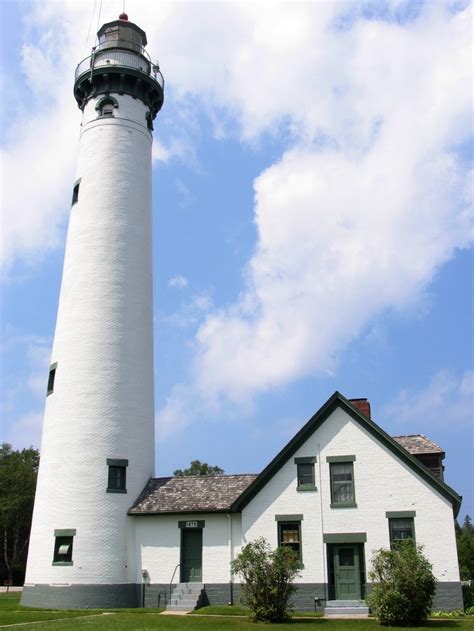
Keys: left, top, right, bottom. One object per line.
{"left": 231, "top": 391, "right": 462, "bottom": 517}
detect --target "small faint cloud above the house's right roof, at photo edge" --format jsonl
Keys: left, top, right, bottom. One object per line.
{"left": 382, "top": 371, "right": 474, "bottom": 429}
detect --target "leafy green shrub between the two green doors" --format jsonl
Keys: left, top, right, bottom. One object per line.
{"left": 231, "top": 537, "right": 300, "bottom": 622}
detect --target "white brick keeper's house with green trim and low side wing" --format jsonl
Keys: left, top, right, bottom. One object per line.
{"left": 129, "top": 392, "right": 462, "bottom": 611}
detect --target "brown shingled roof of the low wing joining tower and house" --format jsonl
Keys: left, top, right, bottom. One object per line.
{"left": 128, "top": 474, "right": 257, "bottom": 515}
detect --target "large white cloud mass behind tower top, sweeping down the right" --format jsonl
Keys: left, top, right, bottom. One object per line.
{"left": 3, "top": 0, "right": 472, "bottom": 440}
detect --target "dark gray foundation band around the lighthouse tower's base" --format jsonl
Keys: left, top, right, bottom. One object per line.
{"left": 21, "top": 583, "right": 141, "bottom": 609}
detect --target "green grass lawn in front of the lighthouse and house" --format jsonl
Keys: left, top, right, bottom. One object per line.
{"left": 0, "top": 593, "right": 474, "bottom": 631}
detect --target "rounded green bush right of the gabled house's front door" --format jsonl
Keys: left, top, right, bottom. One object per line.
{"left": 367, "top": 541, "right": 436, "bottom": 626}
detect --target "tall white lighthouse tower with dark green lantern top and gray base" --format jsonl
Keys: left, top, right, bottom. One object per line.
{"left": 22, "top": 14, "right": 163, "bottom": 607}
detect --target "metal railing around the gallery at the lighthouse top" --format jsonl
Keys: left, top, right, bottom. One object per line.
{"left": 74, "top": 40, "right": 164, "bottom": 88}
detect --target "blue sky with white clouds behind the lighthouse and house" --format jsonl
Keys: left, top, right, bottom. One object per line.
{"left": 0, "top": 0, "right": 474, "bottom": 516}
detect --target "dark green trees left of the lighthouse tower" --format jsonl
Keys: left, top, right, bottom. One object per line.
{"left": 0, "top": 443, "right": 39, "bottom": 584}
